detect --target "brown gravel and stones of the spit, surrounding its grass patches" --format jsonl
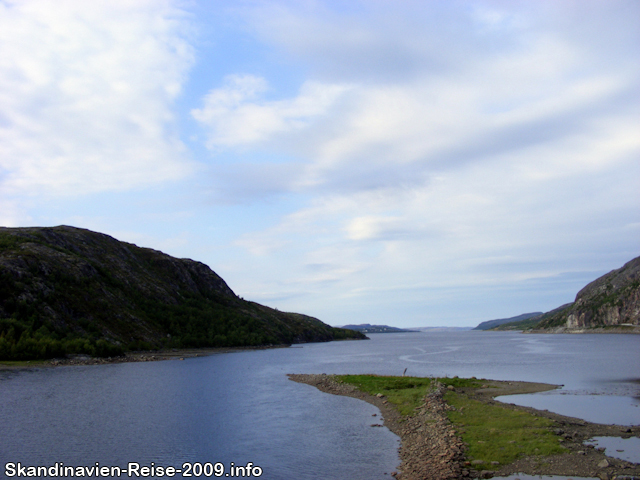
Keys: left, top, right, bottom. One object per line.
{"left": 288, "top": 374, "right": 640, "bottom": 480}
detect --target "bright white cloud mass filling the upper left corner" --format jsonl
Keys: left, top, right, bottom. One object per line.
{"left": 0, "top": 0, "right": 193, "bottom": 196}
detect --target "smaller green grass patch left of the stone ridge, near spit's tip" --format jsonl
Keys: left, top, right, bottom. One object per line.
{"left": 336, "top": 375, "right": 433, "bottom": 415}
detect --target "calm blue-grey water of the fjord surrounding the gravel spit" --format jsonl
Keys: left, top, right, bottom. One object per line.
{"left": 0, "top": 332, "right": 640, "bottom": 480}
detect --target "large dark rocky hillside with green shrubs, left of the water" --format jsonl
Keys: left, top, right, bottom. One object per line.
{"left": 0, "top": 226, "right": 365, "bottom": 359}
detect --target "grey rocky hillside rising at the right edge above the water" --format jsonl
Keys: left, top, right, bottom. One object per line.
{"left": 535, "top": 257, "right": 640, "bottom": 331}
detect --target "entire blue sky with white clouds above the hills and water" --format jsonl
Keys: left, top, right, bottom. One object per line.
{"left": 0, "top": 0, "right": 640, "bottom": 327}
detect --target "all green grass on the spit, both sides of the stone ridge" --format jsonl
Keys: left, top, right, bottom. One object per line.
{"left": 336, "top": 375, "right": 566, "bottom": 468}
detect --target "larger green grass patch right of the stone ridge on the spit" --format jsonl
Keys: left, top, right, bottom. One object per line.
{"left": 444, "top": 392, "right": 566, "bottom": 468}
